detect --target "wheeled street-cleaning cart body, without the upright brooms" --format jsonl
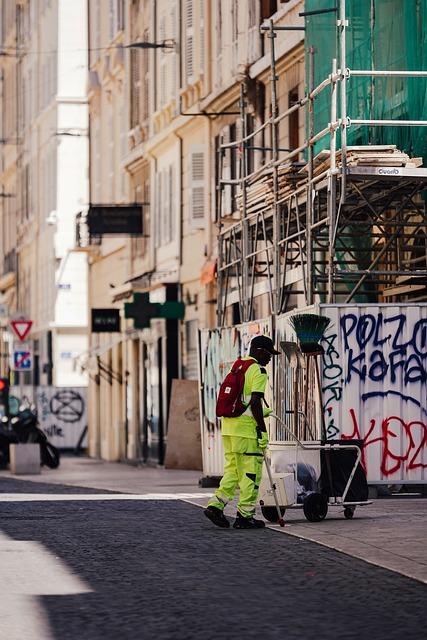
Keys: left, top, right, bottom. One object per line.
{"left": 259, "top": 414, "right": 371, "bottom": 522}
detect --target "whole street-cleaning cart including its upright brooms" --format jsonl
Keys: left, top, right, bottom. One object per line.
{"left": 259, "top": 324, "right": 370, "bottom": 526}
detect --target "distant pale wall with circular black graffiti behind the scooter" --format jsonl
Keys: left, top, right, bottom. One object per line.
{"left": 11, "top": 386, "right": 87, "bottom": 449}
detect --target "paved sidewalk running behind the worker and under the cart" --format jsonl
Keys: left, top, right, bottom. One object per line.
{"left": 0, "top": 457, "right": 427, "bottom": 583}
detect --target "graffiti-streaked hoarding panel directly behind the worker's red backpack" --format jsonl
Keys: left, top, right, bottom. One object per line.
{"left": 200, "top": 320, "right": 272, "bottom": 476}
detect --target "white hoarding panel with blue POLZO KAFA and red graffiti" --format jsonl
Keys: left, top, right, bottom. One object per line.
{"left": 321, "top": 304, "right": 427, "bottom": 484}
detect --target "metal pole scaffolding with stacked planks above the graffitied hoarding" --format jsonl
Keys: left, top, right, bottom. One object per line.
{"left": 217, "top": 0, "right": 427, "bottom": 326}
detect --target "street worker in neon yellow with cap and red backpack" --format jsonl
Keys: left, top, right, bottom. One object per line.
{"left": 204, "top": 336, "right": 280, "bottom": 529}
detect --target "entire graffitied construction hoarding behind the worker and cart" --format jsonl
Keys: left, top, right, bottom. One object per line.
{"left": 201, "top": 304, "right": 427, "bottom": 484}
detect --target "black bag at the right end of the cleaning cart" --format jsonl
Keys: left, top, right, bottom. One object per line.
{"left": 319, "top": 440, "right": 368, "bottom": 502}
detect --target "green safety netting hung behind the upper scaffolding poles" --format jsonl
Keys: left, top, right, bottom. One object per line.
{"left": 305, "top": 0, "right": 427, "bottom": 159}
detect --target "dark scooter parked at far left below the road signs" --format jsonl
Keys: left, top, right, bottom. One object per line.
{"left": 0, "top": 405, "right": 60, "bottom": 469}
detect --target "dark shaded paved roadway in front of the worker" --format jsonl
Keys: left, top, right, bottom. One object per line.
{"left": 0, "top": 481, "right": 427, "bottom": 640}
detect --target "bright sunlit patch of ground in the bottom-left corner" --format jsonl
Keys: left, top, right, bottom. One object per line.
{"left": 0, "top": 532, "right": 92, "bottom": 640}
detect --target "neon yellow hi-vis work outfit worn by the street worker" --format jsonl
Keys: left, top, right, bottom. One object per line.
{"left": 208, "top": 356, "right": 271, "bottom": 518}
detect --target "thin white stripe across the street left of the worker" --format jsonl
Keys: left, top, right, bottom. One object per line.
{"left": 0, "top": 493, "right": 206, "bottom": 502}
